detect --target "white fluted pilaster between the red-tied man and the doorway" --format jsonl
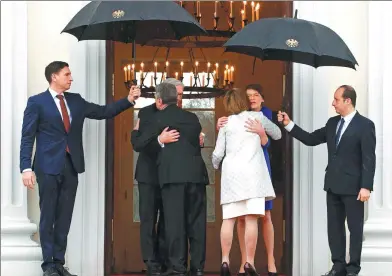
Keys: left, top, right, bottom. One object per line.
{"left": 67, "top": 38, "right": 106, "bottom": 276}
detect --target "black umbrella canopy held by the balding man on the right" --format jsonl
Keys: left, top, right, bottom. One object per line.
{"left": 223, "top": 12, "right": 358, "bottom": 69}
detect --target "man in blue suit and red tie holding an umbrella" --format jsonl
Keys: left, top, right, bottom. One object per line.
{"left": 20, "top": 61, "right": 140, "bottom": 276}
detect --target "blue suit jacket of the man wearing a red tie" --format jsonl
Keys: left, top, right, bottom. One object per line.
{"left": 20, "top": 90, "right": 132, "bottom": 175}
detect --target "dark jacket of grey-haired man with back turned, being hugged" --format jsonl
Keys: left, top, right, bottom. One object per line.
{"left": 134, "top": 104, "right": 209, "bottom": 186}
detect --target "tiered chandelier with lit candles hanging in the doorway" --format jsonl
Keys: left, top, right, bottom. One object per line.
{"left": 123, "top": 1, "right": 260, "bottom": 99}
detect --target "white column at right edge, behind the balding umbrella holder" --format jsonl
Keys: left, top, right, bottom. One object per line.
{"left": 362, "top": 1, "right": 392, "bottom": 276}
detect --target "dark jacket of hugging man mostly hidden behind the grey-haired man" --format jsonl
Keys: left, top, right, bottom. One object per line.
{"left": 131, "top": 103, "right": 160, "bottom": 184}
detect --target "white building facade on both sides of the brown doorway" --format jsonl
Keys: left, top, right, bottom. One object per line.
{"left": 1, "top": 1, "right": 392, "bottom": 276}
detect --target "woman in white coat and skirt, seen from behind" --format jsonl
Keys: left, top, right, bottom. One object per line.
{"left": 212, "top": 89, "right": 282, "bottom": 276}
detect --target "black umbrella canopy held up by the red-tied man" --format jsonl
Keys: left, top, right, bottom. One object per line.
{"left": 62, "top": 1, "right": 206, "bottom": 44}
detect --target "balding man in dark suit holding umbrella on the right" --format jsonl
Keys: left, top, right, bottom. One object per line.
{"left": 278, "top": 85, "right": 376, "bottom": 276}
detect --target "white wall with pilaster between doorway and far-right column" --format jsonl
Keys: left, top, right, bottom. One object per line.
{"left": 292, "top": 1, "right": 368, "bottom": 276}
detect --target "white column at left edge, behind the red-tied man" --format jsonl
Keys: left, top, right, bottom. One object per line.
{"left": 1, "top": 1, "right": 42, "bottom": 276}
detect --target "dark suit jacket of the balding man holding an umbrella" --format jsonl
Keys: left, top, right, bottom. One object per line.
{"left": 290, "top": 112, "right": 376, "bottom": 195}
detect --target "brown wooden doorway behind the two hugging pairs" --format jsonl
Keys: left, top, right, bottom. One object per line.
{"left": 105, "top": 1, "right": 292, "bottom": 276}
